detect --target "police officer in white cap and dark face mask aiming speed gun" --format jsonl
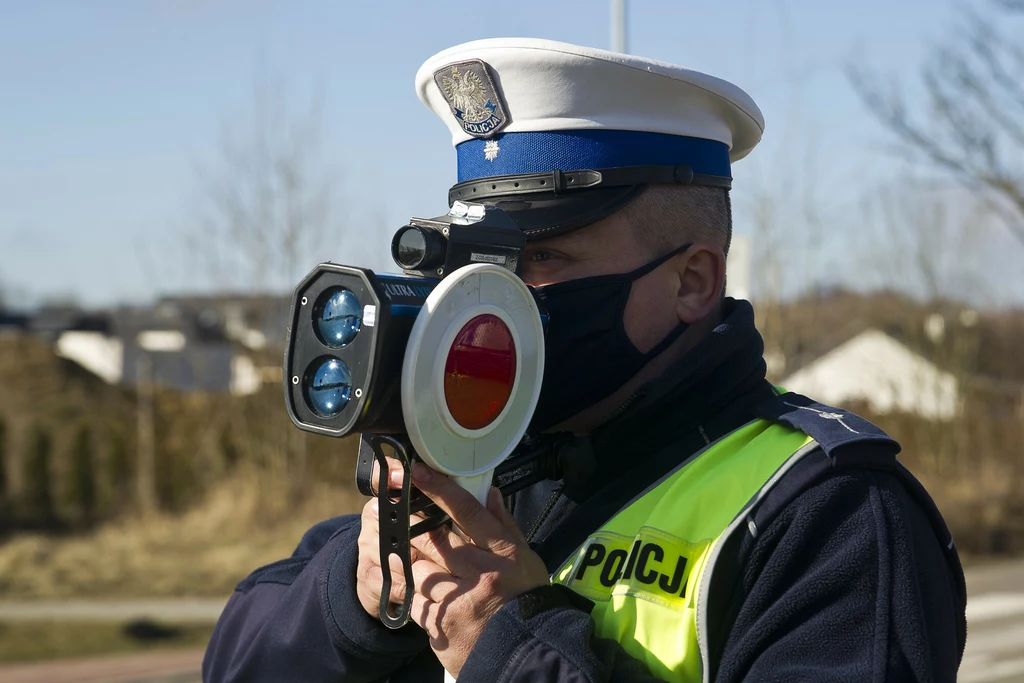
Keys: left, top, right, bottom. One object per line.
{"left": 203, "top": 39, "right": 966, "bottom": 683}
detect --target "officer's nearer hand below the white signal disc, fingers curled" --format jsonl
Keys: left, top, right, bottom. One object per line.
{"left": 405, "top": 463, "right": 549, "bottom": 676}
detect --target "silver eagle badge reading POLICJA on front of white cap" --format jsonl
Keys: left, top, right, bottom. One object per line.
{"left": 434, "top": 59, "right": 509, "bottom": 137}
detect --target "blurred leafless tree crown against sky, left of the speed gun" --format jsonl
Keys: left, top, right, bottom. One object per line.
{"left": 185, "top": 78, "right": 338, "bottom": 293}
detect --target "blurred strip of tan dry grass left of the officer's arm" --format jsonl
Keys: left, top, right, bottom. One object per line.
{"left": 0, "top": 472, "right": 361, "bottom": 599}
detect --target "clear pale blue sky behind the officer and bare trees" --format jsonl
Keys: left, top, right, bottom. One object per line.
{"left": 0, "top": 0, "right": 1024, "bottom": 306}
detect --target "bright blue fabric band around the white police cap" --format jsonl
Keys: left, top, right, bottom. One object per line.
{"left": 456, "top": 128, "right": 732, "bottom": 182}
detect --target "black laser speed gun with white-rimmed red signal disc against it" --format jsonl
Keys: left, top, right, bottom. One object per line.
{"left": 285, "top": 202, "right": 565, "bottom": 628}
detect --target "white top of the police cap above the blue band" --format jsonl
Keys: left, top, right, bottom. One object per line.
{"left": 416, "top": 38, "right": 764, "bottom": 171}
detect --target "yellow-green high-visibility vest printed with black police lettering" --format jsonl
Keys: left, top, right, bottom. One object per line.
{"left": 552, "top": 420, "right": 817, "bottom": 682}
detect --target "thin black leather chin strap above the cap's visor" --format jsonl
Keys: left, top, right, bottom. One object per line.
{"left": 449, "top": 164, "right": 732, "bottom": 206}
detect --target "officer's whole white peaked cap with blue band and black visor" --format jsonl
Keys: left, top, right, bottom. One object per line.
{"left": 416, "top": 38, "right": 764, "bottom": 240}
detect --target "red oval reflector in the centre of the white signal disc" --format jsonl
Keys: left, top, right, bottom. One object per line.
{"left": 444, "top": 314, "right": 515, "bottom": 429}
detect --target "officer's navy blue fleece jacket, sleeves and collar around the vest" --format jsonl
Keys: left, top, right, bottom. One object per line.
{"left": 203, "top": 301, "right": 966, "bottom": 683}
